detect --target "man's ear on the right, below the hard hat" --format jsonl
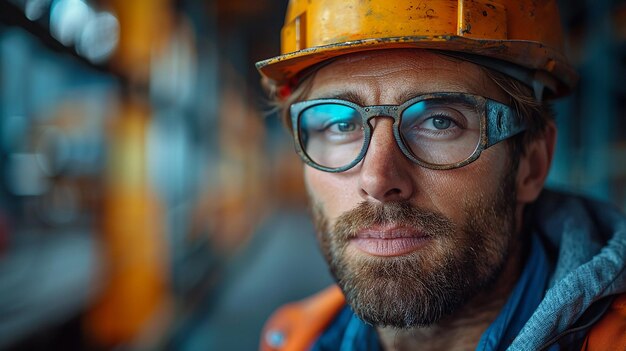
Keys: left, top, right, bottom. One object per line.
{"left": 516, "top": 122, "right": 556, "bottom": 203}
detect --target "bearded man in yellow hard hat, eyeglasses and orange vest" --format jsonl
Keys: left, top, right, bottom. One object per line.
{"left": 257, "top": 0, "right": 626, "bottom": 350}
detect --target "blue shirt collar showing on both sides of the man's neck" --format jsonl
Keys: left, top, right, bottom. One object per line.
{"left": 311, "top": 235, "right": 550, "bottom": 351}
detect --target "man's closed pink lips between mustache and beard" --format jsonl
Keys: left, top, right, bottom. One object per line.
{"left": 350, "top": 226, "right": 429, "bottom": 256}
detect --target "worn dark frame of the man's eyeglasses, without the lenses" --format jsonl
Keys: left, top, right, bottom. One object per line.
{"left": 289, "top": 92, "right": 527, "bottom": 173}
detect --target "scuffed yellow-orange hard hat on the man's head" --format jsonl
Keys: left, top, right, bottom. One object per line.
{"left": 256, "top": 0, "right": 577, "bottom": 95}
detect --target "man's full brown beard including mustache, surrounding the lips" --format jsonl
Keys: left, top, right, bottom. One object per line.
{"left": 313, "top": 172, "right": 516, "bottom": 328}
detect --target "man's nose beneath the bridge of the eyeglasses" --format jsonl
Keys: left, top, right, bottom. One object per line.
{"left": 359, "top": 117, "right": 415, "bottom": 203}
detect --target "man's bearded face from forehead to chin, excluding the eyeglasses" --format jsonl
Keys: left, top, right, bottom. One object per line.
{"left": 305, "top": 50, "right": 516, "bottom": 327}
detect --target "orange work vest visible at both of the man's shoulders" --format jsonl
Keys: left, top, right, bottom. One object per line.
{"left": 260, "top": 285, "right": 626, "bottom": 351}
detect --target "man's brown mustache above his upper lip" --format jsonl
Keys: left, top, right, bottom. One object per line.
{"left": 332, "top": 201, "right": 455, "bottom": 241}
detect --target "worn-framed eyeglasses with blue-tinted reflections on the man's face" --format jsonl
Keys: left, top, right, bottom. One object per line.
{"left": 290, "top": 93, "right": 526, "bottom": 172}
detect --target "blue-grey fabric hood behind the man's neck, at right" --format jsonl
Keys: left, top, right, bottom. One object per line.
{"left": 509, "top": 190, "right": 626, "bottom": 351}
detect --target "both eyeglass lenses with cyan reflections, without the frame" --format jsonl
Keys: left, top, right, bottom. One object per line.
{"left": 298, "top": 97, "right": 481, "bottom": 168}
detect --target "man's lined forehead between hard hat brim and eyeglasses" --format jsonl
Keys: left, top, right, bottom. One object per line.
{"left": 308, "top": 50, "right": 504, "bottom": 105}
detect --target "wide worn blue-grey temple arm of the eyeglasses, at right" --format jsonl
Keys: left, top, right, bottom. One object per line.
{"left": 485, "top": 100, "right": 526, "bottom": 148}
